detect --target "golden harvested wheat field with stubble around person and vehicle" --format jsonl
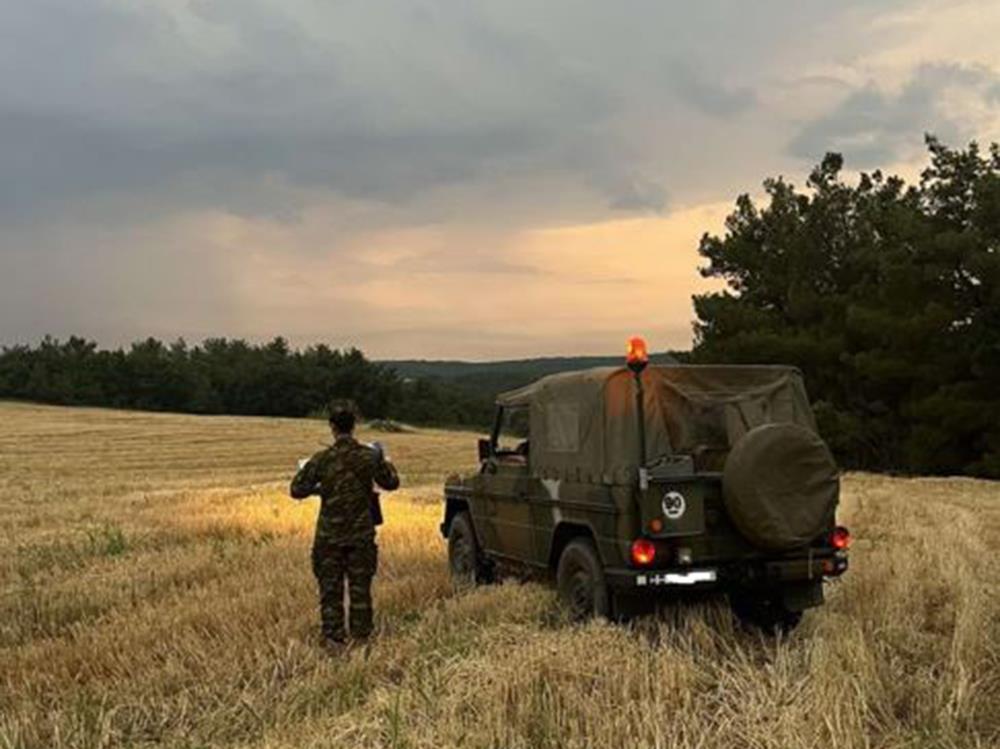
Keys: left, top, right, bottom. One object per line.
{"left": 0, "top": 404, "right": 1000, "bottom": 748}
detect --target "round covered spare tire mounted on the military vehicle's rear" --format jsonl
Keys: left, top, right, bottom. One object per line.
{"left": 722, "top": 423, "right": 840, "bottom": 551}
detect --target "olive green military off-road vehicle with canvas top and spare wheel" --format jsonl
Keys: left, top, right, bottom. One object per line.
{"left": 441, "top": 359, "right": 850, "bottom": 630}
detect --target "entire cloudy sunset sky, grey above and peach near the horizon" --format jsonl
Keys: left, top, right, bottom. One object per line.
{"left": 0, "top": 0, "right": 1000, "bottom": 359}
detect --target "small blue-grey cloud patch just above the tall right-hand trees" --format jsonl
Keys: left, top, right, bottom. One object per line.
{"left": 789, "top": 65, "right": 992, "bottom": 168}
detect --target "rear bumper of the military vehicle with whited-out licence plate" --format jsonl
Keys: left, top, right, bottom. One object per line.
{"left": 604, "top": 552, "right": 848, "bottom": 592}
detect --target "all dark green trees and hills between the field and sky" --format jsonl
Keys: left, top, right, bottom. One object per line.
{"left": 0, "top": 137, "right": 1000, "bottom": 478}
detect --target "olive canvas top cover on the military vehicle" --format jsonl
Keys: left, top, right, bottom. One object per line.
{"left": 497, "top": 365, "right": 816, "bottom": 484}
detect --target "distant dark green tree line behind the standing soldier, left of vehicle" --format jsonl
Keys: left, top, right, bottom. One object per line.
{"left": 0, "top": 336, "right": 492, "bottom": 426}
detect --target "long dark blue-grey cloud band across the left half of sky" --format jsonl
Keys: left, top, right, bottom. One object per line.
{"left": 0, "top": 108, "right": 542, "bottom": 218}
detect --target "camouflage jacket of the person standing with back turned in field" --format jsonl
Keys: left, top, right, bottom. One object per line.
{"left": 291, "top": 436, "right": 399, "bottom": 543}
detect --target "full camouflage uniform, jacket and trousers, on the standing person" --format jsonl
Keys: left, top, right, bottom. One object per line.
{"left": 291, "top": 435, "right": 399, "bottom": 640}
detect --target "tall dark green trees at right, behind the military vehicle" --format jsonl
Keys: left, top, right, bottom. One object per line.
{"left": 693, "top": 136, "right": 1000, "bottom": 477}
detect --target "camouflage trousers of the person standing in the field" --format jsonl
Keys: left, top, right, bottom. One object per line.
{"left": 312, "top": 538, "right": 378, "bottom": 640}
